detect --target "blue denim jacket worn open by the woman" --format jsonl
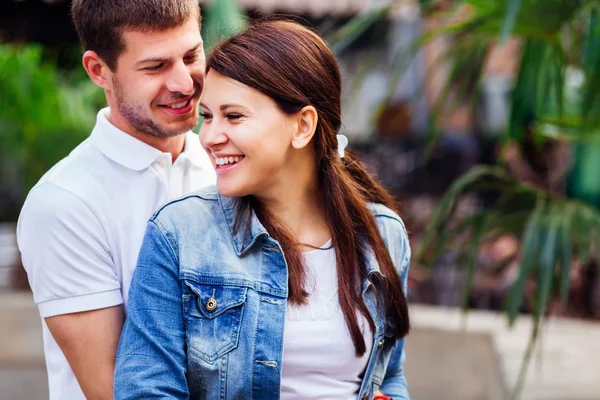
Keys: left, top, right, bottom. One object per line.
{"left": 115, "top": 188, "right": 410, "bottom": 400}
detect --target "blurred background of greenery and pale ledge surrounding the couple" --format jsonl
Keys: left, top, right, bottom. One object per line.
{"left": 0, "top": 0, "right": 600, "bottom": 400}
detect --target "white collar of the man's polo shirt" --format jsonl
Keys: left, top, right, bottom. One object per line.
{"left": 91, "top": 107, "right": 204, "bottom": 171}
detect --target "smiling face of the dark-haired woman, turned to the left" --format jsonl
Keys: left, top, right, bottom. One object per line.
{"left": 200, "top": 70, "right": 298, "bottom": 197}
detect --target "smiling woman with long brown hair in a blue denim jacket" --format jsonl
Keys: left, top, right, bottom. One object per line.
{"left": 115, "top": 21, "right": 410, "bottom": 399}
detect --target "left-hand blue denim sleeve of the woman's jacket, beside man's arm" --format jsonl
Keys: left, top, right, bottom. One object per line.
{"left": 114, "top": 220, "right": 189, "bottom": 400}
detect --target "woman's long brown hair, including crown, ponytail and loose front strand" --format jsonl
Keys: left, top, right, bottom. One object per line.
{"left": 206, "top": 20, "right": 409, "bottom": 355}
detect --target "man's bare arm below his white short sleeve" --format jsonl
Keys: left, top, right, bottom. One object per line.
{"left": 46, "top": 305, "right": 124, "bottom": 400}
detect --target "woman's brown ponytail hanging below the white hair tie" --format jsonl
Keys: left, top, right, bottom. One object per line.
{"left": 319, "top": 149, "right": 410, "bottom": 355}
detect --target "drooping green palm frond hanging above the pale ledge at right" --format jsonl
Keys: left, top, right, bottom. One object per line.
{"left": 415, "top": 167, "right": 600, "bottom": 396}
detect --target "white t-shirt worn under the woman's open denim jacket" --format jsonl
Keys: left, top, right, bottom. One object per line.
{"left": 281, "top": 241, "right": 373, "bottom": 400}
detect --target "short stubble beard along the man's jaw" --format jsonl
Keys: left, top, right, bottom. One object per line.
{"left": 113, "top": 79, "right": 199, "bottom": 139}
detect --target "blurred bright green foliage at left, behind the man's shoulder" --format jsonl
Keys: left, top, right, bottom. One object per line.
{"left": 0, "top": 44, "right": 104, "bottom": 218}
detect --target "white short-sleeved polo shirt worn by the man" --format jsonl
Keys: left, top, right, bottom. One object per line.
{"left": 17, "top": 108, "right": 215, "bottom": 400}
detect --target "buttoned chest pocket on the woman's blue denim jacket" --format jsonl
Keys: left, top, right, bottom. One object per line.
{"left": 184, "top": 281, "right": 248, "bottom": 364}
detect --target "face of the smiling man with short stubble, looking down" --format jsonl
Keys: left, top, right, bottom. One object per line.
{"left": 107, "top": 18, "right": 206, "bottom": 138}
